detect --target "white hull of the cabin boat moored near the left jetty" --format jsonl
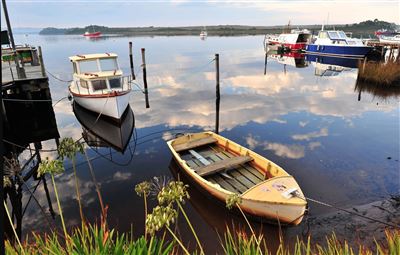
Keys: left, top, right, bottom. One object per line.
{"left": 74, "top": 93, "right": 130, "bottom": 119}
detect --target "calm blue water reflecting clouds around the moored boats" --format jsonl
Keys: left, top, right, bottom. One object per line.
{"left": 16, "top": 35, "right": 400, "bottom": 251}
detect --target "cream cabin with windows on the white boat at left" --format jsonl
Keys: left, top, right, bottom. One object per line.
{"left": 69, "top": 53, "right": 130, "bottom": 94}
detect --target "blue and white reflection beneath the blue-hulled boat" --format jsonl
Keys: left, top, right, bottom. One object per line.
{"left": 305, "top": 54, "right": 359, "bottom": 76}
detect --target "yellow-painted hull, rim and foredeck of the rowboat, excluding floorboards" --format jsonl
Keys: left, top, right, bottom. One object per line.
{"left": 168, "top": 132, "right": 307, "bottom": 225}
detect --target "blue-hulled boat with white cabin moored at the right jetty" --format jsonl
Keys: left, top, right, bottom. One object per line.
{"left": 306, "top": 30, "right": 372, "bottom": 58}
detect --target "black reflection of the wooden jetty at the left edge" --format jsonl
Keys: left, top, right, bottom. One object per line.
{"left": 1, "top": 82, "right": 60, "bottom": 240}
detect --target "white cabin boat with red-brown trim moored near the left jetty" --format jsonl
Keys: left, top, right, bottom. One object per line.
{"left": 69, "top": 53, "right": 131, "bottom": 120}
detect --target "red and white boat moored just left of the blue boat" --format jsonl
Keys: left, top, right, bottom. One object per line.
{"left": 264, "top": 29, "right": 311, "bottom": 51}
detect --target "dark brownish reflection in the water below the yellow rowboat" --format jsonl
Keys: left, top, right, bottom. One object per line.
{"left": 169, "top": 159, "right": 285, "bottom": 251}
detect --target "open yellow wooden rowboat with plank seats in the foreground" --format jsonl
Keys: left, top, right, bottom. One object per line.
{"left": 167, "top": 132, "right": 307, "bottom": 225}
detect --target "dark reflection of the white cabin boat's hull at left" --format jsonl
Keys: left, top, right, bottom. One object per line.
{"left": 73, "top": 102, "right": 135, "bottom": 153}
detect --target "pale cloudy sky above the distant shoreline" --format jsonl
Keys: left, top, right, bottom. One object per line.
{"left": 1, "top": 0, "right": 400, "bottom": 28}
